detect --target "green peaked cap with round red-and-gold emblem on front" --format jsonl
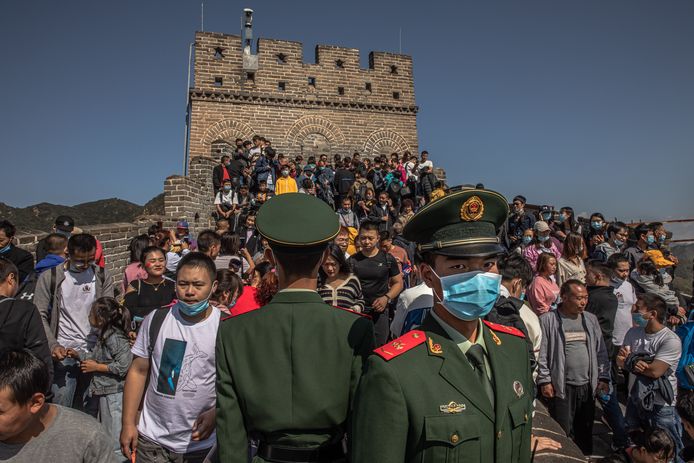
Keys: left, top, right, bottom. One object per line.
{"left": 403, "top": 188, "right": 509, "bottom": 257}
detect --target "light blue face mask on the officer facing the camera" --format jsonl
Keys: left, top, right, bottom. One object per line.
{"left": 432, "top": 269, "right": 501, "bottom": 321}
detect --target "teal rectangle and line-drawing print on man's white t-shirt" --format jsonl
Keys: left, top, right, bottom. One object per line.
{"left": 157, "top": 338, "right": 208, "bottom": 396}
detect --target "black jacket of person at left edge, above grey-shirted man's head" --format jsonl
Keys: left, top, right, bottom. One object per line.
{"left": 0, "top": 296, "right": 53, "bottom": 385}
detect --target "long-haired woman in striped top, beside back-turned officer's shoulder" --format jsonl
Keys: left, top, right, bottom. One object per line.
{"left": 318, "top": 244, "right": 364, "bottom": 312}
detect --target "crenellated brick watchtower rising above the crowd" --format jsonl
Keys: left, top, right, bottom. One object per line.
{"left": 190, "top": 32, "right": 418, "bottom": 159}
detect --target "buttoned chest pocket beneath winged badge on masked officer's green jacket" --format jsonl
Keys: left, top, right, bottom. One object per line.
{"left": 422, "top": 412, "right": 481, "bottom": 463}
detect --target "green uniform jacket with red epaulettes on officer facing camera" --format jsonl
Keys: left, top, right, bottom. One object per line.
{"left": 352, "top": 316, "right": 534, "bottom": 463}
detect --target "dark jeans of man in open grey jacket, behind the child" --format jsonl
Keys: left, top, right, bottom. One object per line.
{"left": 51, "top": 358, "right": 93, "bottom": 415}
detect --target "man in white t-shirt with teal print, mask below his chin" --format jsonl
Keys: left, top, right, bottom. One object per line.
{"left": 121, "top": 252, "right": 221, "bottom": 463}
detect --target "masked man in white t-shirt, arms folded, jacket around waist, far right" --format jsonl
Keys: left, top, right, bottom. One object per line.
{"left": 617, "top": 293, "right": 682, "bottom": 455}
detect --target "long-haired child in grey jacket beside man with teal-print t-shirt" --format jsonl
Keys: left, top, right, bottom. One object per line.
{"left": 68, "top": 297, "right": 132, "bottom": 457}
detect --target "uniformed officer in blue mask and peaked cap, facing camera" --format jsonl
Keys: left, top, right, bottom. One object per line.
{"left": 352, "top": 189, "right": 534, "bottom": 463}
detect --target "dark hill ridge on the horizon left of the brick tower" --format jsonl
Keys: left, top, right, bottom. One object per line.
{"left": 0, "top": 193, "right": 164, "bottom": 234}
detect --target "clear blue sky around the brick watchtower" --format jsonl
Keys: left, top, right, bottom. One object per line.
{"left": 0, "top": 0, "right": 694, "bottom": 228}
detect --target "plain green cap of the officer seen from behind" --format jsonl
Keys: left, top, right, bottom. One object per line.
{"left": 255, "top": 193, "right": 340, "bottom": 248}
